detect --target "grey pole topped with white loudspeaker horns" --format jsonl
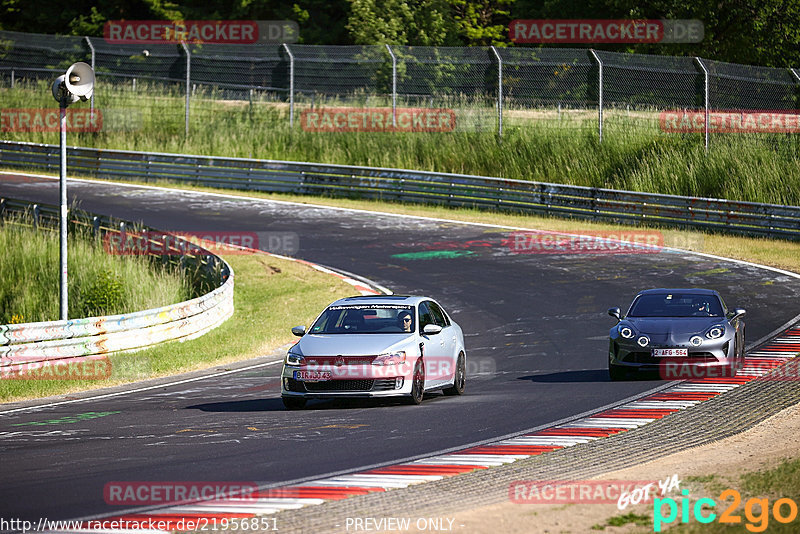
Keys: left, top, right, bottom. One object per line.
{"left": 52, "top": 61, "right": 94, "bottom": 321}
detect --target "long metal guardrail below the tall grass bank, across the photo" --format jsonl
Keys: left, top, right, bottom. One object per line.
{"left": 0, "top": 141, "right": 800, "bottom": 239}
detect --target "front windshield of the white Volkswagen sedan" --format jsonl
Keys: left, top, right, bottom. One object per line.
{"left": 310, "top": 304, "right": 415, "bottom": 334}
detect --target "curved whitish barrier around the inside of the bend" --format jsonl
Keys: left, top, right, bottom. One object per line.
{"left": 0, "top": 199, "right": 233, "bottom": 376}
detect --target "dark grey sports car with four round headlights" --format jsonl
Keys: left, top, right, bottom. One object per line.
{"left": 608, "top": 289, "right": 745, "bottom": 380}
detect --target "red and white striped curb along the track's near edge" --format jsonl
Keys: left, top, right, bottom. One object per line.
{"left": 51, "top": 326, "right": 800, "bottom": 533}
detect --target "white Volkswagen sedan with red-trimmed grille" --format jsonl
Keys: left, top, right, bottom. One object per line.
{"left": 281, "top": 295, "right": 466, "bottom": 410}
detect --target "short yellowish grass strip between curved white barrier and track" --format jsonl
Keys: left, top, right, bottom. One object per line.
{"left": 0, "top": 249, "right": 354, "bottom": 402}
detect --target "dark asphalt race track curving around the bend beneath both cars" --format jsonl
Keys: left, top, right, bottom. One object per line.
{"left": 0, "top": 175, "right": 800, "bottom": 520}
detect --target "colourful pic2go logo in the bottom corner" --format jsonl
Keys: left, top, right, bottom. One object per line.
{"left": 653, "top": 489, "right": 797, "bottom": 532}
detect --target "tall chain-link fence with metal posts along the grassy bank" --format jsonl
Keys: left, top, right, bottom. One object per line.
{"left": 0, "top": 32, "right": 800, "bottom": 147}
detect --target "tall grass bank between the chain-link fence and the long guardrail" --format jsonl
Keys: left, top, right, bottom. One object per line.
{"left": 0, "top": 82, "right": 800, "bottom": 205}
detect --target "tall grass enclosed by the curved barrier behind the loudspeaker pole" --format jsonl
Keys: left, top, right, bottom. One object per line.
{"left": 0, "top": 220, "right": 190, "bottom": 324}
